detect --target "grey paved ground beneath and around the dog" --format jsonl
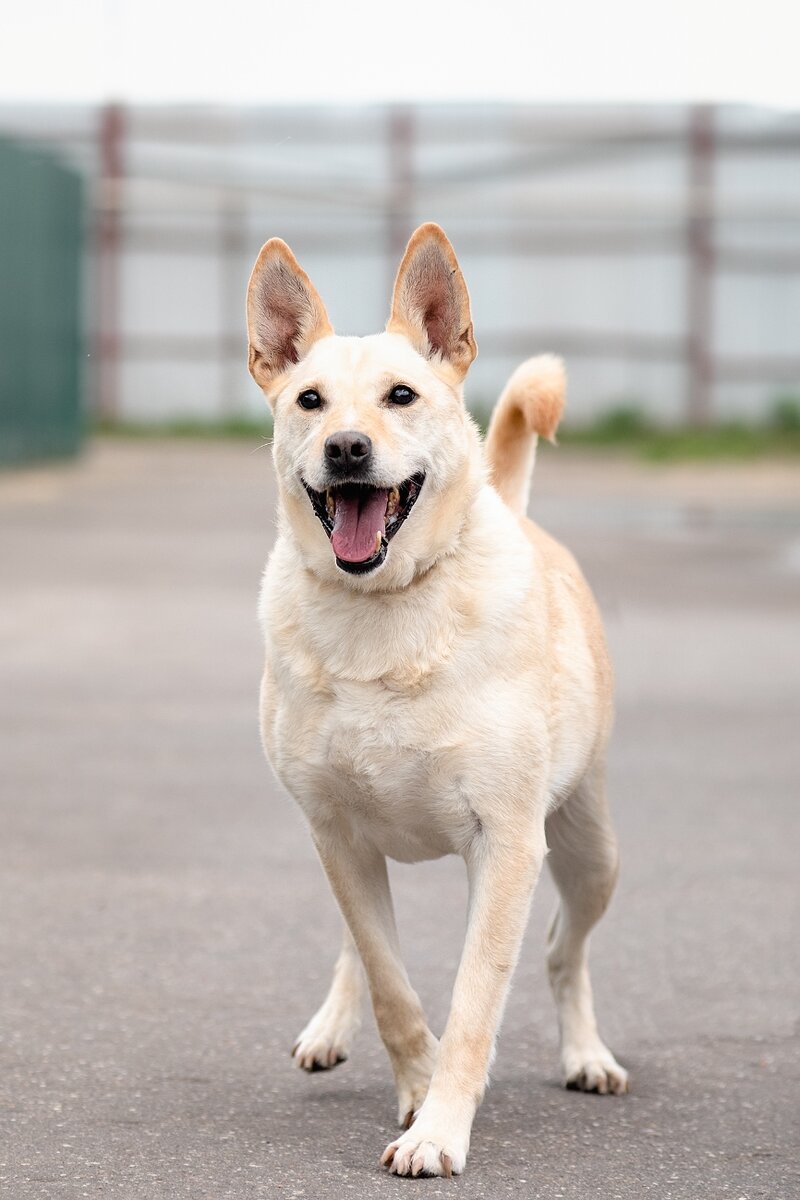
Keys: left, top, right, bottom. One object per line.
{"left": 0, "top": 443, "right": 800, "bottom": 1200}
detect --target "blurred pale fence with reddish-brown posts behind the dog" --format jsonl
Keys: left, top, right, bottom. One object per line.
{"left": 0, "top": 106, "right": 800, "bottom": 422}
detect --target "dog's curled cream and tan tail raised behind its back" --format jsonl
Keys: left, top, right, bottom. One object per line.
{"left": 486, "top": 354, "right": 566, "bottom": 514}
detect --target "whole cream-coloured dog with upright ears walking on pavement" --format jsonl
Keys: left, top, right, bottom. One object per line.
{"left": 247, "top": 224, "right": 627, "bottom": 1175}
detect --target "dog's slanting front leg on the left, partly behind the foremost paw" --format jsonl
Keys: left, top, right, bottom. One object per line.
{"left": 314, "top": 829, "right": 438, "bottom": 1128}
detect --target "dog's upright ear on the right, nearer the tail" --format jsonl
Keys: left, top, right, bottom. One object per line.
{"left": 386, "top": 223, "right": 477, "bottom": 379}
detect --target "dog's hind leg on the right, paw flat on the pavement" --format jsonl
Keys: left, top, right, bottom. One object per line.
{"left": 546, "top": 763, "right": 627, "bottom": 1094}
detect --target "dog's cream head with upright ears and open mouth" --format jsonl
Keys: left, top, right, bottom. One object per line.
{"left": 247, "top": 224, "right": 482, "bottom": 589}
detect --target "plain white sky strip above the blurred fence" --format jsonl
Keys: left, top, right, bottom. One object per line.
{"left": 0, "top": 0, "right": 800, "bottom": 109}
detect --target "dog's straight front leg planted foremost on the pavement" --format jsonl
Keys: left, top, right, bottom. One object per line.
{"left": 381, "top": 827, "right": 545, "bottom": 1175}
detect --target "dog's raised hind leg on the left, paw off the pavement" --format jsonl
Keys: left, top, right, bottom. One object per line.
{"left": 291, "top": 925, "right": 363, "bottom": 1070}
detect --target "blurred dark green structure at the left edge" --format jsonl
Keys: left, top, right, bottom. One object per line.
{"left": 0, "top": 139, "right": 84, "bottom": 463}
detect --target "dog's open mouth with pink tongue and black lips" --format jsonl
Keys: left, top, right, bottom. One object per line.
{"left": 302, "top": 474, "right": 425, "bottom": 575}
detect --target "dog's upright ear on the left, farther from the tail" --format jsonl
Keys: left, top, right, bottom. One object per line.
{"left": 247, "top": 238, "right": 333, "bottom": 392}
